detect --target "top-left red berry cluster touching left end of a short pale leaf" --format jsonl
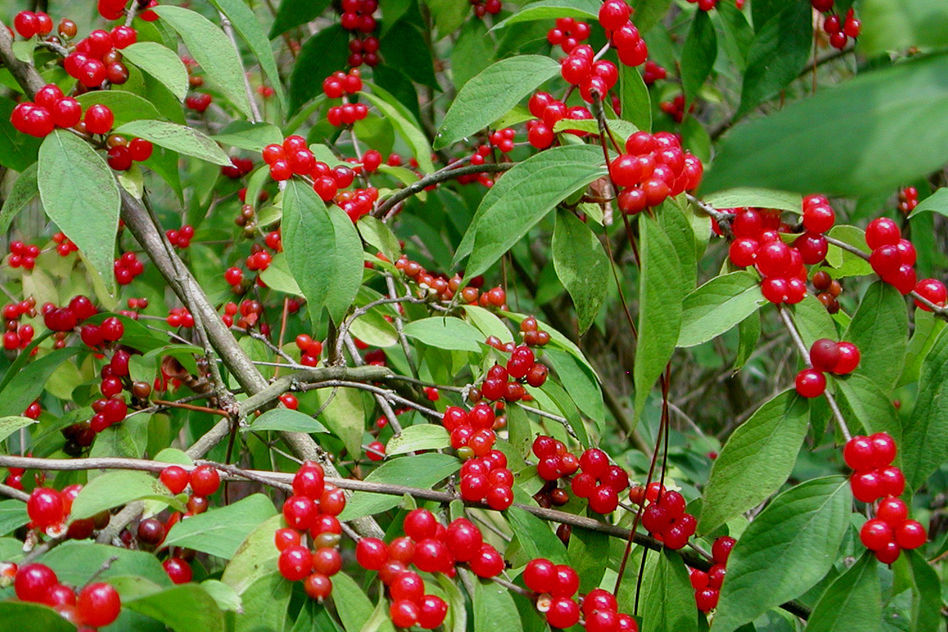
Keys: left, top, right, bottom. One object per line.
{"left": 63, "top": 26, "right": 138, "bottom": 89}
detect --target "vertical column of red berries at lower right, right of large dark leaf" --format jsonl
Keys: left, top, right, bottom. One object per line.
{"left": 843, "top": 432, "right": 928, "bottom": 564}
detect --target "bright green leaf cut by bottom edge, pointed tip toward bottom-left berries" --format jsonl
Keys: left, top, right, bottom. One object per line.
{"left": 122, "top": 584, "right": 225, "bottom": 632}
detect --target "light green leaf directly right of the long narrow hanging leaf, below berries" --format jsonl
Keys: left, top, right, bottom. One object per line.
{"left": 678, "top": 271, "right": 767, "bottom": 347}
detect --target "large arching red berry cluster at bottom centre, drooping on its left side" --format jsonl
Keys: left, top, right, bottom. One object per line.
{"left": 356, "top": 509, "right": 504, "bottom": 630}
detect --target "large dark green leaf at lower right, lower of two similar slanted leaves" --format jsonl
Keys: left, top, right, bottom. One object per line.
{"left": 714, "top": 476, "right": 852, "bottom": 632}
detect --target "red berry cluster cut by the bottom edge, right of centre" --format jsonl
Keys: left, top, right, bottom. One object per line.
{"left": 523, "top": 557, "right": 638, "bottom": 632}
